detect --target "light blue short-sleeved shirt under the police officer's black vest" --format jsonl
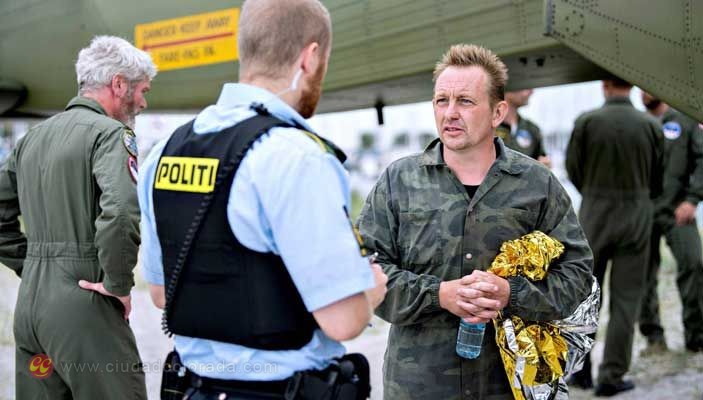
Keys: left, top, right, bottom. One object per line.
{"left": 137, "top": 83, "right": 374, "bottom": 380}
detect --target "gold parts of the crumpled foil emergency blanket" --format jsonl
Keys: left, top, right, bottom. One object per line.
{"left": 488, "top": 231, "right": 568, "bottom": 400}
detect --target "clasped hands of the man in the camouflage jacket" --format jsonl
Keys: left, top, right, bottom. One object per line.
{"left": 457, "top": 270, "right": 510, "bottom": 323}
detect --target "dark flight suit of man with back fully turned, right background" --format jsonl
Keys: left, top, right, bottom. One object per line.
{"left": 566, "top": 97, "right": 664, "bottom": 384}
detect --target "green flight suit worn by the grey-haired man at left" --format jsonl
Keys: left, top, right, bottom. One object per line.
{"left": 0, "top": 97, "right": 146, "bottom": 400}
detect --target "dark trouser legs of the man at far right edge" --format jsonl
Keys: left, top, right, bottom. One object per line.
{"left": 640, "top": 221, "right": 703, "bottom": 345}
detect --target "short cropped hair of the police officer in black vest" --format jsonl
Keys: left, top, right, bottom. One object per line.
{"left": 237, "top": 0, "right": 332, "bottom": 78}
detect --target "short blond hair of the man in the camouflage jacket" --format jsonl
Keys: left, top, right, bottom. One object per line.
{"left": 432, "top": 44, "right": 508, "bottom": 104}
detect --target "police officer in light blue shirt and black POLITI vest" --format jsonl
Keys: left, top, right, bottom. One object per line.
{"left": 138, "top": 0, "right": 387, "bottom": 399}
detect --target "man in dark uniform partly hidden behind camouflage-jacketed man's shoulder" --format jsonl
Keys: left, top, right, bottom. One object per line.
{"left": 496, "top": 89, "right": 551, "bottom": 167}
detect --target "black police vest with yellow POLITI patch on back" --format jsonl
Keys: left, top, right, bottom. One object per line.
{"left": 153, "top": 107, "right": 343, "bottom": 350}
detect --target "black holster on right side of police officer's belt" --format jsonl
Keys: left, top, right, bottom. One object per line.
{"left": 285, "top": 353, "right": 371, "bottom": 400}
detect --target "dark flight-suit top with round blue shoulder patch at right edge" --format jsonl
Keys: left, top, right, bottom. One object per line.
{"left": 656, "top": 108, "right": 703, "bottom": 228}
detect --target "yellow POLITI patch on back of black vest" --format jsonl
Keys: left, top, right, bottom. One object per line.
{"left": 154, "top": 157, "right": 220, "bottom": 193}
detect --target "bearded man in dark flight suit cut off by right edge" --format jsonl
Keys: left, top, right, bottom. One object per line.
{"left": 640, "top": 92, "right": 703, "bottom": 354}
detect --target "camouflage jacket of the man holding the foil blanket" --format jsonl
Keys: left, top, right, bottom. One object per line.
{"left": 359, "top": 138, "right": 592, "bottom": 400}
